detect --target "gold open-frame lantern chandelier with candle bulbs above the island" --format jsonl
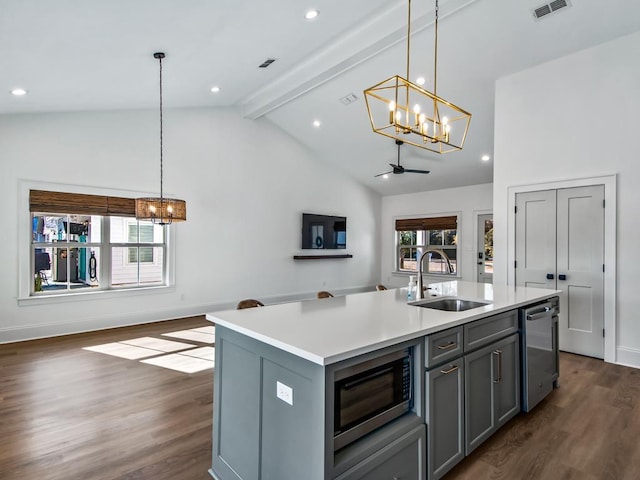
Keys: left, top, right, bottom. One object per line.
{"left": 364, "top": 0, "right": 471, "bottom": 153}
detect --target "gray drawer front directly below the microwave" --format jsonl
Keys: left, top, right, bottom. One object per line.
{"left": 335, "top": 425, "right": 426, "bottom": 480}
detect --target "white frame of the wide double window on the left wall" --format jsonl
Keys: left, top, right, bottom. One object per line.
{"left": 17, "top": 180, "right": 176, "bottom": 305}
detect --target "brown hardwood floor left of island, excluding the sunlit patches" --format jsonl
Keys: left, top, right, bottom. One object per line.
{"left": 0, "top": 317, "right": 213, "bottom": 480}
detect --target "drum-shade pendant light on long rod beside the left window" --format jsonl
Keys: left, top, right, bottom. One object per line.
{"left": 136, "top": 52, "right": 187, "bottom": 225}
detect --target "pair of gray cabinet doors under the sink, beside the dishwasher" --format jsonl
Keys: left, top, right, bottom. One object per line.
{"left": 464, "top": 334, "right": 520, "bottom": 455}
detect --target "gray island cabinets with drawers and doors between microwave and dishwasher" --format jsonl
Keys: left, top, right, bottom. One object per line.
{"left": 425, "top": 310, "right": 520, "bottom": 480}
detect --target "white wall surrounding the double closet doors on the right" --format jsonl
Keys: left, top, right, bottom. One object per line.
{"left": 493, "top": 29, "right": 640, "bottom": 367}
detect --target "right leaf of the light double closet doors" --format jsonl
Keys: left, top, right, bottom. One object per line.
{"left": 557, "top": 185, "right": 604, "bottom": 358}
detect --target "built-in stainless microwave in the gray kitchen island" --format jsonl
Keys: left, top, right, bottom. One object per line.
{"left": 334, "top": 348, "right": 413, "bottom": 450}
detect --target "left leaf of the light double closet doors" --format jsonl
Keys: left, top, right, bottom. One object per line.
{"left": 515, "top": 190, "right": 556, "bottom": 288}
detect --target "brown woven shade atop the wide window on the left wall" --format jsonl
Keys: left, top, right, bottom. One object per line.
{"left": 29, "top": 190, "right": 136, "bottom": 217}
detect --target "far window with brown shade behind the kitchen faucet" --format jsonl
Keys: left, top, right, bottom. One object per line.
{"left": 396, "top": 215, "right": 458, "bottom": 276}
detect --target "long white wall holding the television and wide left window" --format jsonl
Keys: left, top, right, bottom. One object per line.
{"left": 0, "top": 109, "right": 380, "bottom": 342}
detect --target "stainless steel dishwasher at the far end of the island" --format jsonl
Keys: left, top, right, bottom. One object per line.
{"left": 520, "top": 297, "right": 560, "bottom": 412}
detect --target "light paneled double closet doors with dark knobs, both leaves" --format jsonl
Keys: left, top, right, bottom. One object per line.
{"left": 515, "top": 185, "right": 605, "bottom": 358}
